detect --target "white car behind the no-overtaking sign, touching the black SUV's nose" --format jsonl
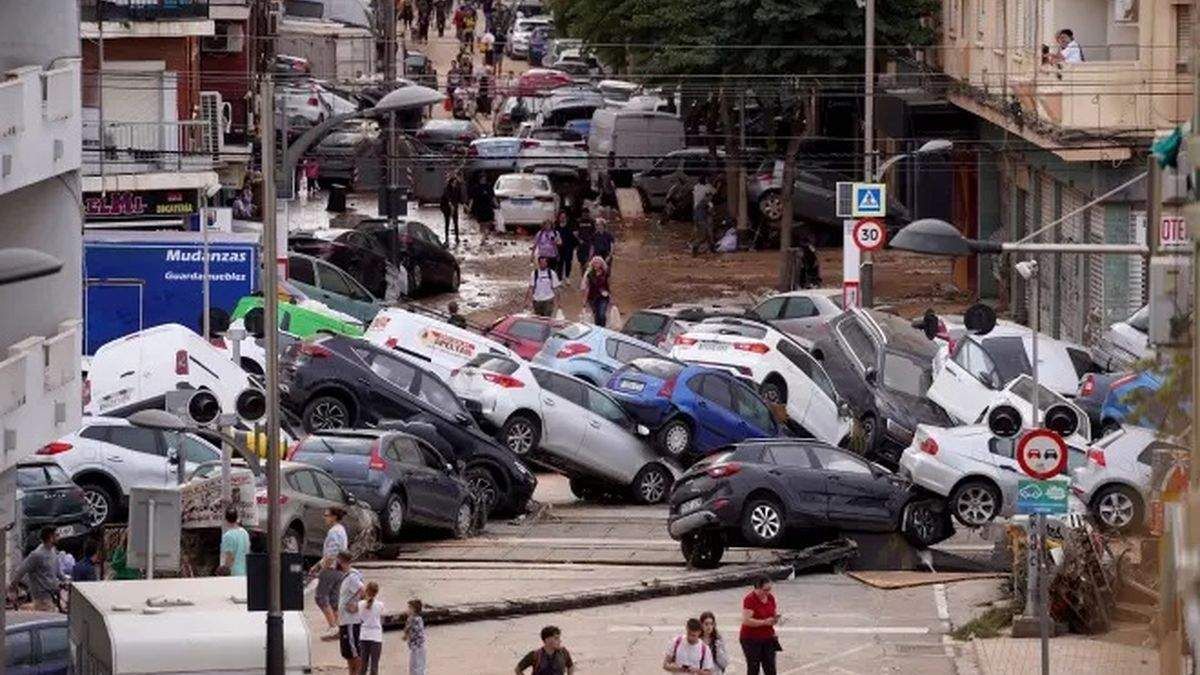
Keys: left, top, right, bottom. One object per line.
{"left": 900, "top": 424, "right": 1087, "bottom": 527}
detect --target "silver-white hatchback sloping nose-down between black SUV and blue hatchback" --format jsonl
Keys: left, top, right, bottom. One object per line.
{"left": 450, "top": 354, "right": 683, "bottom": 504}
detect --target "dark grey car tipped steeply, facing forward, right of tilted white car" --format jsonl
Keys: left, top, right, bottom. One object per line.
{"left": 811, "top": 309, "right": 954, "bottom": 466}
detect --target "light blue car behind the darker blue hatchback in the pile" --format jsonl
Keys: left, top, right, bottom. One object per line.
{"left": 533, "top": 323, "right": 667, "bottom": 387}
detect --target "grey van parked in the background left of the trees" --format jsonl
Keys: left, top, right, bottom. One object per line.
{"left": 588, "top": 108, "right": 684, "bottom": 187}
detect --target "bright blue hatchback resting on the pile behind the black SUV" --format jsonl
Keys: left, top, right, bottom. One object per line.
{"left": 607, "top": 357, "right": 784, "bottom": 465}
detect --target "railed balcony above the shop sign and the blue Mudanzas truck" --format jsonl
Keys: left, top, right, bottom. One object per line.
{"left": 83, "top": 115, "right": 220, "bottom": 175}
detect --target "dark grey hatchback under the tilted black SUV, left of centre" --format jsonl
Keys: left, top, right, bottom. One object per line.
{"left": 289, "top": 429, "right": 475, "bottom": 540}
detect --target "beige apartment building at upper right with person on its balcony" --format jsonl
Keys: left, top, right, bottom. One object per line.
{"left": 938, "top": 0, "right": 1195, "bottom": 341}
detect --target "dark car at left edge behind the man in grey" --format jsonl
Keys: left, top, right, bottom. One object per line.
{"left": 17, "top": 460, "right": 91, "bottom": 552}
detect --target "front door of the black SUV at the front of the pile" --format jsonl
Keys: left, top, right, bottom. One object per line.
{"left": 809, "top": 444, "right": 898, "bottom": 531}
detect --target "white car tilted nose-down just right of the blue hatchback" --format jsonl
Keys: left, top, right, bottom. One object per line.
{"left": 671, "top": 317, "right": 852, "bottom": 444}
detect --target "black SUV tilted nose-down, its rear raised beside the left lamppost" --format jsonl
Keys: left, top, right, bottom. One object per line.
{"left": 280, "top": 336, "right": 538, "bottom": 513}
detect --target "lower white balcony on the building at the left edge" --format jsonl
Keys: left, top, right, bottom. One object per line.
{"left": 0, "top": 321, "right": 83, "bottom": 470}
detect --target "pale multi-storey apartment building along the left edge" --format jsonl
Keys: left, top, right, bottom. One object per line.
{"left": 0, "top": 0, "right": 83, "bottom": 470}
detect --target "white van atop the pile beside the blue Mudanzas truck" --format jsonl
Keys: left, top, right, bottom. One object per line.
{"left": 83, "top": 323, "right": 257, "bottom": 416}
